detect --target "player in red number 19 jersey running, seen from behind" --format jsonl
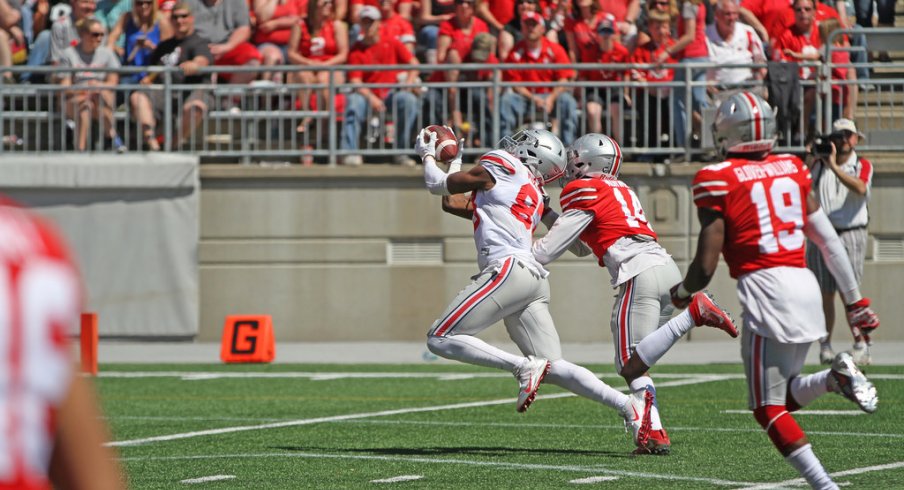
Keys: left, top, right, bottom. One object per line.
{"left": 672, "top": 92, "right": 879, "bottom": 489}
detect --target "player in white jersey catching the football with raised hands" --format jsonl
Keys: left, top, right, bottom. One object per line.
{"left": 415, "top": 129, "right": 653, "bottom": 447}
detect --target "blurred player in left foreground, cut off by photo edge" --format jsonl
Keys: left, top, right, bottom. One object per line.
{"left": 0, "top": 197, "right": 124, "bottom": 490}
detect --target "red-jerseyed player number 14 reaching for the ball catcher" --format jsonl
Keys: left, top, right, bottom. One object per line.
{"left": 533, "top": 133, "right": 738, "bottom": 454}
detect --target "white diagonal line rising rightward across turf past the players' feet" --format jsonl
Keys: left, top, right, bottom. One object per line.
{"left": 106, "top": 375, "right": 724, "bottom": 447}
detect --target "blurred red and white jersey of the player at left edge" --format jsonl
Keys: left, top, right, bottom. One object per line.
{"left": 0, "top": 202, "right": 81, "bottom": 488}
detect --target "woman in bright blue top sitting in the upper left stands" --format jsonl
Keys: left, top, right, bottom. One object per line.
{"left": 107, "top": 0, "right": 173, "bottom": 83}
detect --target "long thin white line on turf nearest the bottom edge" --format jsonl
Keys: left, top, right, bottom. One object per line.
{"left": 119, "top": 452, "right": 755, "bottom": 487}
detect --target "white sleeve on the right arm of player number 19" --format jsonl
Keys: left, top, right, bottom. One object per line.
{"left": 804, "top": 208, "right": 863, "bottom": 305}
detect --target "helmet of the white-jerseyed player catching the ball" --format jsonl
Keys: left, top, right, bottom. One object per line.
{"left": 496, "top": 129, "right": 565, "bottom": 184}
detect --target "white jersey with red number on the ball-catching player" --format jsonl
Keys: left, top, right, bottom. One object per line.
{"left": 473, "top": 150, "right": 549, "bottom": 277}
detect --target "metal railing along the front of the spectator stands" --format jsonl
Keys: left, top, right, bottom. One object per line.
{"left": 0, "top": 57, "right": 904, "bottom": 164}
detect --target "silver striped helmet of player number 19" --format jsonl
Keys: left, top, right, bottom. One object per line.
{"left": 713, "top": 92, "right": 776, "bottom": 156}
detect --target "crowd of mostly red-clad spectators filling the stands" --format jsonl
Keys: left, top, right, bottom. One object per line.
{"left": 0, "top": 0, "right": 894, "bottom": 161}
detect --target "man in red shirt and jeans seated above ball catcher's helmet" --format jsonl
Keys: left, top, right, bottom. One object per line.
{"left": 500, "top": 12, "right": 578, "bottom": 145}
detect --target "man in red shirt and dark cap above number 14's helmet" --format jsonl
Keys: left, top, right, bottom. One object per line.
{"left": 578, "top": 15, "right": 631, "bottom": 140}
